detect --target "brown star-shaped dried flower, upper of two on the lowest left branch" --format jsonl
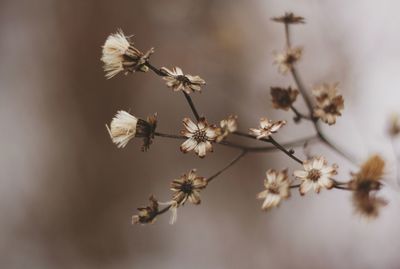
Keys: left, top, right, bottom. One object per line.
{"left": 171, "top": 169, "right": 207, "bottom": 205}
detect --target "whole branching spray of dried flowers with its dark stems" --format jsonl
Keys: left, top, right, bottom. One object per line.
{"left": 101, "top": 13, "right": 392, "bottom": 224}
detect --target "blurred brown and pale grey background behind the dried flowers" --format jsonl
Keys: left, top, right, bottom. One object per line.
{"left": 0, "top": 0, "right": 400, "bottom": 269}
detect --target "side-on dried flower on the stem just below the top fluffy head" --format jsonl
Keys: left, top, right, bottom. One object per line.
{"left": 161, "top": 67, "right": 206, "bottom": 94}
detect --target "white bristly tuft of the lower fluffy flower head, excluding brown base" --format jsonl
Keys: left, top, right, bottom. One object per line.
{"left": 106, "top": 110, "right": 138, "bottom": 148}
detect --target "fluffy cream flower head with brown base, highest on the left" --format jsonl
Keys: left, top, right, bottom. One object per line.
{"left": 101, "top": 30, "right": 154, "bottom": 79}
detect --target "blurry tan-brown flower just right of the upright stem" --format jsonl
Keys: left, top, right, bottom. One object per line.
{"left": 313, "top": 83, "right": 344, "bottom": 125}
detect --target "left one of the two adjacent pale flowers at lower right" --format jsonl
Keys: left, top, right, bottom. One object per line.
{"left": 257, "top": 169, "right": 290, "bottom": 210}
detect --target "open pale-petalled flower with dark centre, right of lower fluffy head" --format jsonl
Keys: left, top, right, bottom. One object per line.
{"left": 181, "top": 118, "right": 218, "bottom": 158}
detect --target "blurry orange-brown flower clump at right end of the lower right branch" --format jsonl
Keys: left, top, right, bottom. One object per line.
{"left": 348, "top": 155, "right": 387, "bottom": 217}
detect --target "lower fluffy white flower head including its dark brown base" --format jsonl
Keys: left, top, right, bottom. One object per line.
{"left": 106, "top": 110, "right": 157, "bottom": 151}
